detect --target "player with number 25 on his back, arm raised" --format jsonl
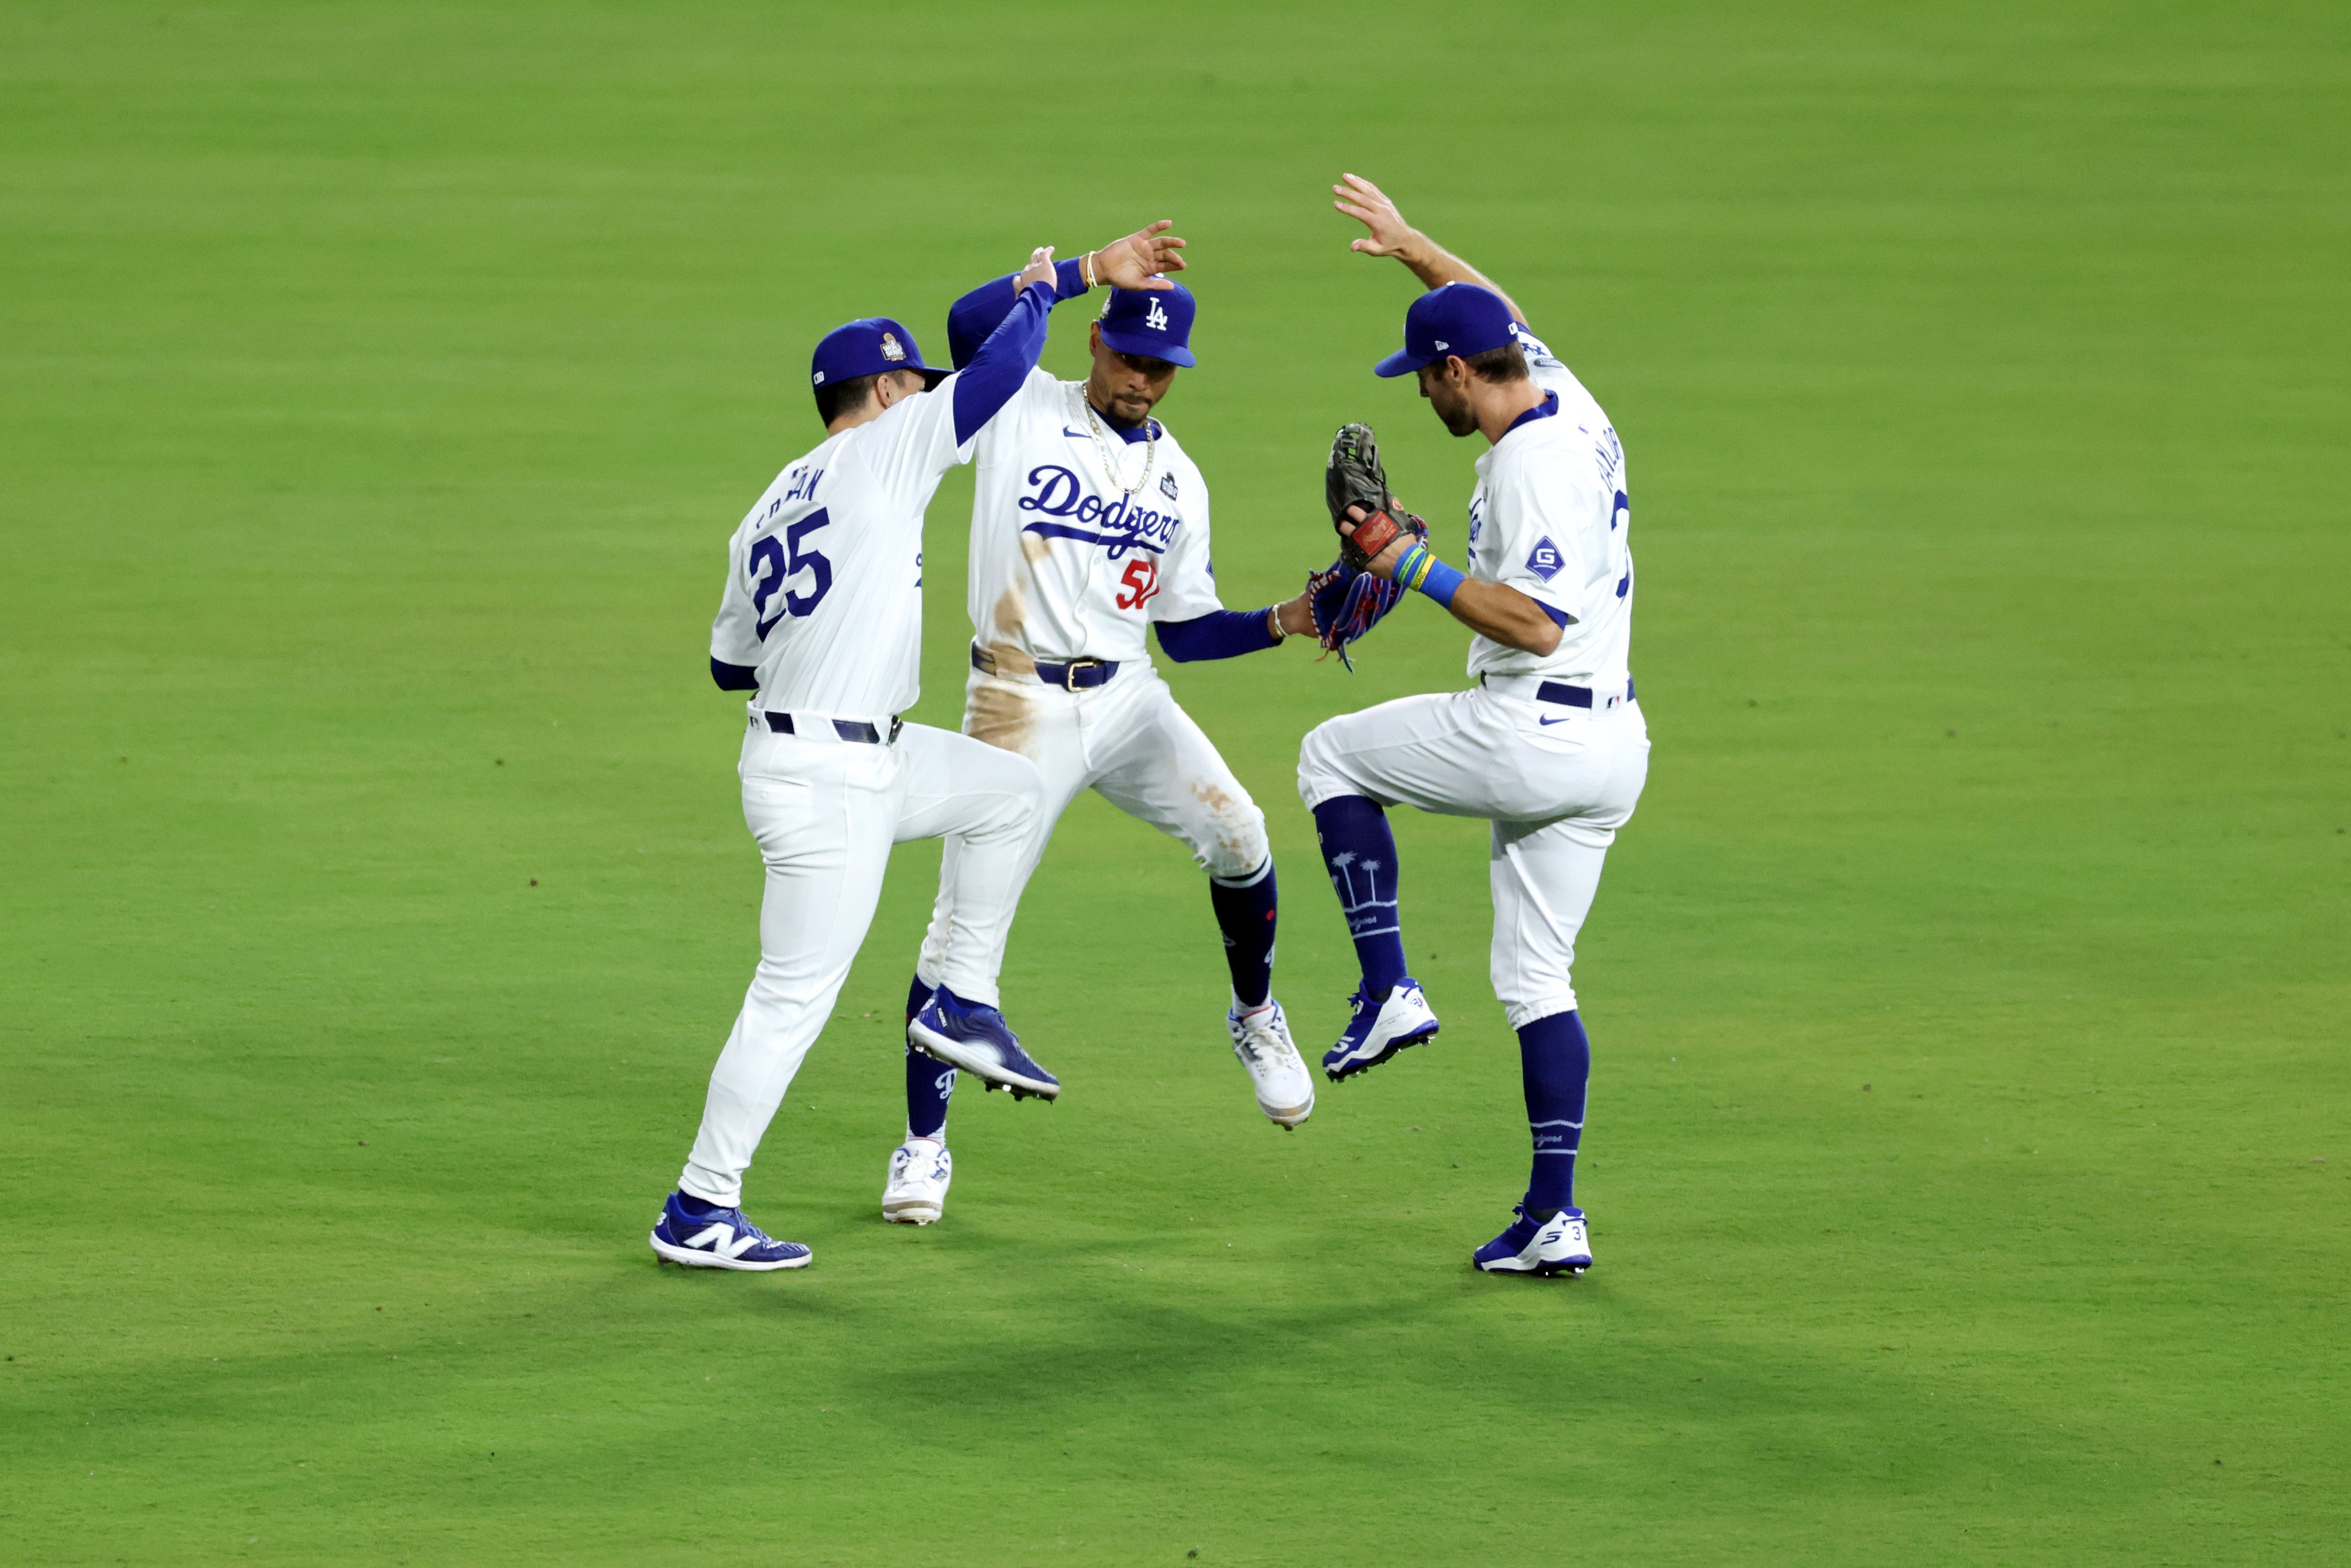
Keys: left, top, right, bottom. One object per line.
{"left": 651, "top": 223, "right": 1182, "bottom": 1270}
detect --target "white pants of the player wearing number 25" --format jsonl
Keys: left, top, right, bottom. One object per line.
{"left": 677, "top": 715, "right": 1044, "bottom": 1208}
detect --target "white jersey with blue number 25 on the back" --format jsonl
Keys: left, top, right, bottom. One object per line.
{"left": 710, "top": 376, "right": 978, "bottom": 721}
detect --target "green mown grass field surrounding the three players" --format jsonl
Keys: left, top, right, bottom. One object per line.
{"left": 0, "top": 0, "right": 2351, "bottom": 1568}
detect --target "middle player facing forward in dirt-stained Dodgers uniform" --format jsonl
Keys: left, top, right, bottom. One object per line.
{"left": 882, "top": 256, "right": 1314, "bottom": 1225}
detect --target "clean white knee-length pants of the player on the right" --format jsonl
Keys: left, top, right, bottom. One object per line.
{"left": 1298, "top": 677, "right": 1648, "bottom": 1030}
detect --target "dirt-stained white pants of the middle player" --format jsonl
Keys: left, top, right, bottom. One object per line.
{"left": 914, "top": 661, "right": 1272, "bottom": 997}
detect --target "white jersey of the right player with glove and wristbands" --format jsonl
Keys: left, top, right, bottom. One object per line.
{"left": 1469, "top": 327, "right": 1632, "bottom": 684}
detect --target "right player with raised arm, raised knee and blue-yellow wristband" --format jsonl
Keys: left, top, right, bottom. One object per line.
{"left": 1298, "top": 174, "right": 1648, "bottom": 1274}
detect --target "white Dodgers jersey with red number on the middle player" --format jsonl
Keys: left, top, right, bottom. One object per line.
{"left": 969, "top": 369, "right": 1223, "bottom": 663}
